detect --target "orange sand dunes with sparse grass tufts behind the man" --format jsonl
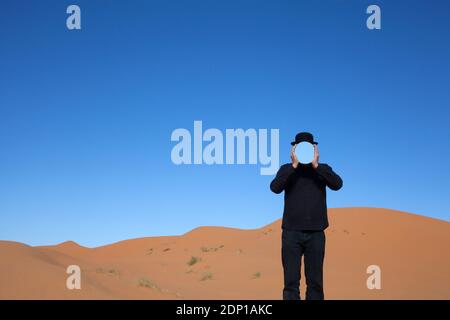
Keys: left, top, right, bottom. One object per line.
{"left": 0, "top": 208, "right": 450, "bottom": 299}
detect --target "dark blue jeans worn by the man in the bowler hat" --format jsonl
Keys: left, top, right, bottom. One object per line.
{"left": 281, "top": 229, "right": 325, "bottom": 300}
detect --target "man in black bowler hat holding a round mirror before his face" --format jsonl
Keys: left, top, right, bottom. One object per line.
{"left": 270, "top": 132, "right": 342, "bottom": 300}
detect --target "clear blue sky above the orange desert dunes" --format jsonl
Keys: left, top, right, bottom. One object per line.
{"left": 0, "top": 0, "right": 450, "bottom": 246}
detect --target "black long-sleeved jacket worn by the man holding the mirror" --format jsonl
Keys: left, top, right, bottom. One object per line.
{"left": 270, "top": 163, "right": 342, "bottom": 230}
